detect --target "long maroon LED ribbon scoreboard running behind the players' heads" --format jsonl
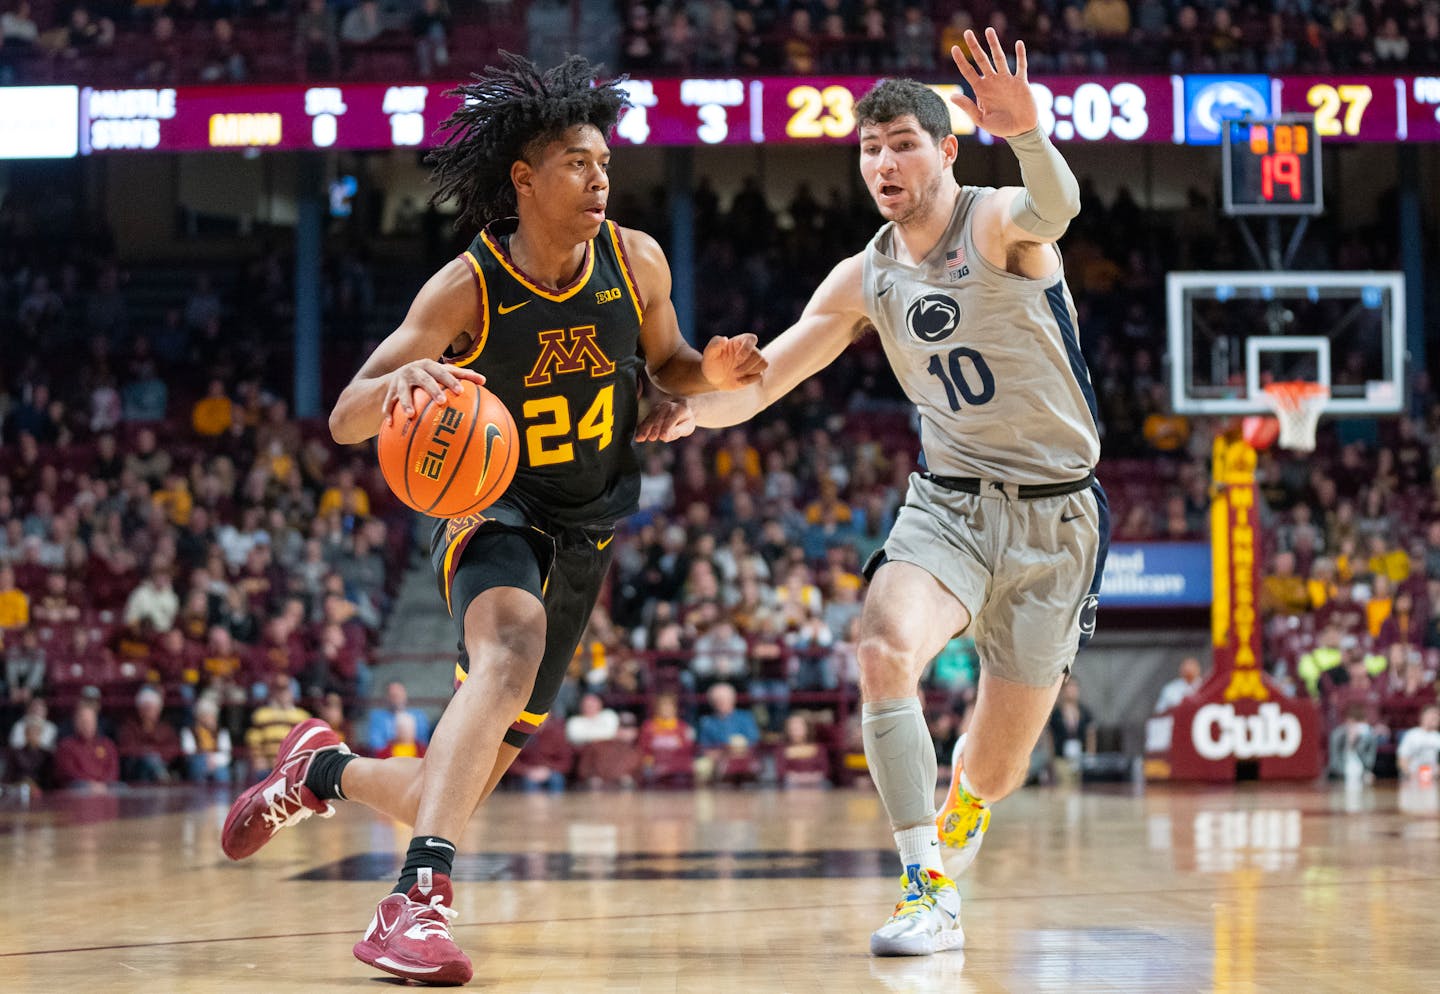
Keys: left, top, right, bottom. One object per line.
{"left": 0, "top": 73, "right": 1440, "bottom": 157}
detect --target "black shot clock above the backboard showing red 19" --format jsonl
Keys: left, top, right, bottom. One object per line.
{"left": 1223, "top": 115, "right": 1325, "bottom": 215}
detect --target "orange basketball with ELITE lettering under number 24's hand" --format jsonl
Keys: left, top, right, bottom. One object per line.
{"left": 379, "top": 380, "right": 520, "bottom": 517}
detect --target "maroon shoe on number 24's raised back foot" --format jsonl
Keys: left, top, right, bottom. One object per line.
{"left": 220, "top": 717, "right": 350, "bottom": 860}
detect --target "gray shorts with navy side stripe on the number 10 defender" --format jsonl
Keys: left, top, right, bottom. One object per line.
{"left": 884, "top": 474, "right": 1110, "bottom": 687}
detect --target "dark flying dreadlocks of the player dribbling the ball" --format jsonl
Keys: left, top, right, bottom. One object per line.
{"left": 425, "top": 52, "right": 628, "bottom": 230}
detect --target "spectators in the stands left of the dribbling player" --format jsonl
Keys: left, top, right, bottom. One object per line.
{"left": 0, "top": 182, "right": 410, "bottom": 784}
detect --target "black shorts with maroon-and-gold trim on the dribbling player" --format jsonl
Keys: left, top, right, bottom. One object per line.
{"left": 431, "top": 498, "right": 615, "bottom": 748}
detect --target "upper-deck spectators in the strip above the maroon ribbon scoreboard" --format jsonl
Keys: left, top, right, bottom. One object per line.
{"left": 0, "top": 0, "right": 1440, "bottom": 85}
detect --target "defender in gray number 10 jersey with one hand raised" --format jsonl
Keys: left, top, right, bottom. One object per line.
{"left": 655, "top": 29, "right": 1109, "bottom": 955}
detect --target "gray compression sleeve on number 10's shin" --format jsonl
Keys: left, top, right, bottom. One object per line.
{"left": 860, "top": 697, "right": 936, "bottom": 830}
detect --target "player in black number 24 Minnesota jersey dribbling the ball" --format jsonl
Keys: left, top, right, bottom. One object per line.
{"left": 222, "top": 56, "right": 765, "bottom": 984}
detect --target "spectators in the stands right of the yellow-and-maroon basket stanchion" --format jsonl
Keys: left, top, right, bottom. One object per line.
{"left": 1260, "top": 437, "right": 1440, "bottom": 775}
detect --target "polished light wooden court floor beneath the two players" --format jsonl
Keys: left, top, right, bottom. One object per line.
{"left": 0, "top": 785, "right": 1440, "bottom": 994}
